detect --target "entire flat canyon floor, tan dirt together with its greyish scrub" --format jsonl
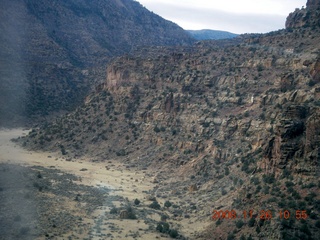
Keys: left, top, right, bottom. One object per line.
{"left": 0, "top": 129, "right": 210, "bottom": 239}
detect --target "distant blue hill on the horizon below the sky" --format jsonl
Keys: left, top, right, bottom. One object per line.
{"left": 187, "top": 29, "right": 238, "bottom": 40}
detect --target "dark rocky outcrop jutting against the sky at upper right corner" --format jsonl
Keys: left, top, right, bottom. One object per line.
{"left": 286, "top": 0, "right": 320, "bottom": 28}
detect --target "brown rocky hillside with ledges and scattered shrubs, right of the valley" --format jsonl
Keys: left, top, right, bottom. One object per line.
{"left": 19, "top": 1, "right": 320, "bottom": 239}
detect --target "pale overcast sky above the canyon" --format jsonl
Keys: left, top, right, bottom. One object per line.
{"left": 138, "top": 0, "right": 307, "bottom": 33}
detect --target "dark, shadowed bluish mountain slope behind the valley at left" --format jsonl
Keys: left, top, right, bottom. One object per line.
{"left": 0, "top": 0, "right": 193, "bottom": 125}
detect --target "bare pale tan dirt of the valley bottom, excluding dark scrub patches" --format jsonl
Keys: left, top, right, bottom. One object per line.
{"left": 0, "top": 129, "right": 209, "bottom": 240}
